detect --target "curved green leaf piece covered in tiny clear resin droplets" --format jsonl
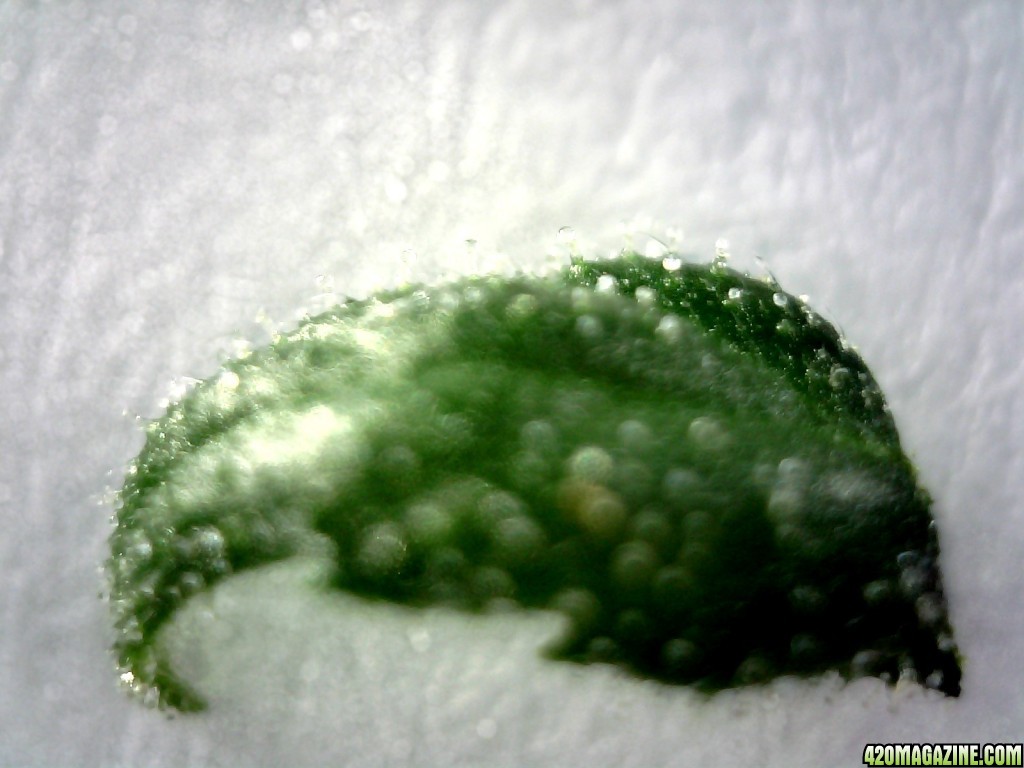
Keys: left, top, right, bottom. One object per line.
{"left": 109, "top": 254, "right": 961, "bottom": 710}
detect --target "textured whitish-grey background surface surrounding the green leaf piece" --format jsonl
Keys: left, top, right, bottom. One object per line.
{"left": 0, "top": 0, "right": 1024, "bottom": 766}
